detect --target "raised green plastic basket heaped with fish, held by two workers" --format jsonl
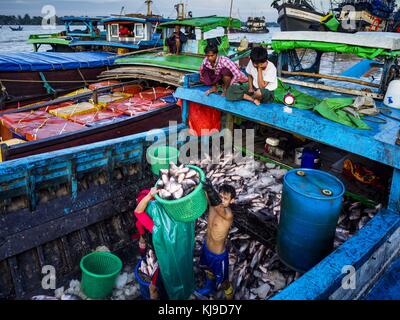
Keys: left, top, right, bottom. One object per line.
{"left": 155, "top": 165, "right": 207, "bottom": 222}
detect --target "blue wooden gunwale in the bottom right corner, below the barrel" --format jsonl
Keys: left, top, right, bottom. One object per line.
{"left": 271, "top": 209, "right": 400, "bottom": 300}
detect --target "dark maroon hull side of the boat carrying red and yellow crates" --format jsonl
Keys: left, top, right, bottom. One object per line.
{"left": 2, "top": 105, "right": 181, "bottom": 161}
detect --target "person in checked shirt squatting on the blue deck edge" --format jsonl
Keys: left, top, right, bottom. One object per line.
{"left": 200, "top": 44, "right": 248, "bottom": 96}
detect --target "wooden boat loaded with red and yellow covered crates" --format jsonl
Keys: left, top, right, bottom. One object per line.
{"left": 0, "top": 81, "right": 179, "bottom": 161}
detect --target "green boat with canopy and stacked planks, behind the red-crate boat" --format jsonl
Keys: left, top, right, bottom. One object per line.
{"left": 101, "top": 16, "right": 250, "bottom": 86}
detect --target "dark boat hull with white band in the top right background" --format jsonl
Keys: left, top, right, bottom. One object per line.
{"left": 271, "top": 0, "right": 325, "bottom": 31}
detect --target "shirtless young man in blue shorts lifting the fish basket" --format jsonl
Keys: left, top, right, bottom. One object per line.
{"left": 195, "top": 181, "right": 236, "bottom": 300}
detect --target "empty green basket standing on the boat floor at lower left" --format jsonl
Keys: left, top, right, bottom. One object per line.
{"left": 80, "top": 252, "right": 122, "bottom": 299}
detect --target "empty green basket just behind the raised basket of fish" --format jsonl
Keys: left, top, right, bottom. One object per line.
{"left": 147, "top": 146, "right": 179, "bottom": 176}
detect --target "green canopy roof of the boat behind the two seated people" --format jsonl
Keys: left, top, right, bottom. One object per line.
{"left": 160, "top": 16, "right": 242, "bottom": 32}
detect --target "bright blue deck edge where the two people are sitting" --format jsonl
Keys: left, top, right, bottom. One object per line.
{"left": 175, "top": 86, "right": 400, "bottom": 169}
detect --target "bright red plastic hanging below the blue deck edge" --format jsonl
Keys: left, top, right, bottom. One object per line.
{"left": 189, "top": 102, "right": 221, "bottom": 136}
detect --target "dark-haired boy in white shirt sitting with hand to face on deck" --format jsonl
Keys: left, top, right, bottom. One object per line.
{"left": 227, "top": 47, "right": 278, "bottom": 106}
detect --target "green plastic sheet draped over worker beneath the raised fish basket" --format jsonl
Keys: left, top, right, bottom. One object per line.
{"left": 146, "top": 201, "right": 195, "bottom": 300}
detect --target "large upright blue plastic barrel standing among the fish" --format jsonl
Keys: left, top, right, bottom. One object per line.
{"left": 277, "top": 169, "right": 345, "bottom": 272}
